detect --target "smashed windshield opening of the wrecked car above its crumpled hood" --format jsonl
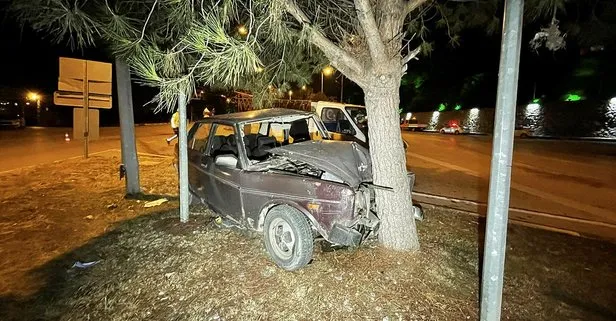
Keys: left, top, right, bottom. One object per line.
{"left": 242, "top": 116, "right": 327, "bottom": 163}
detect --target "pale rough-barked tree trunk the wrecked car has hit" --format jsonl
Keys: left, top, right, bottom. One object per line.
{"left": 364, "top": 72, "right": 419, "bottom": 251}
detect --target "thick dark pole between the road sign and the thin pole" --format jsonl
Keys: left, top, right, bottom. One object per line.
{"left": 115, "top": 59, "right": 141, "bottom": 195}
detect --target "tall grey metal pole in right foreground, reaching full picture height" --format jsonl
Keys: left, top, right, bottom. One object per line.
{"left": 480, "top": 0, "right": 524, "bottom": 321}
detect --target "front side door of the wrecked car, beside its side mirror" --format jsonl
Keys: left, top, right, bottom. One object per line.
{"left": 201, "top": 124, "right": 243, "bottom": 222}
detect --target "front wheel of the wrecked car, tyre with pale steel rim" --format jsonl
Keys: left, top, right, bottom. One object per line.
{"left": 263, "top": 206, "right": 314, "bottom": 271}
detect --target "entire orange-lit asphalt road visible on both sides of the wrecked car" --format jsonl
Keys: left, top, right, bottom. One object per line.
{"left": 0, "top": 124, "right": 616, "bottom": 240}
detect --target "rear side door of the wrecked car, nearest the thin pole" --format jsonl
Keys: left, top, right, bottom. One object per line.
{"left": 188, "top": 123, "right": 212, "bottom": 202}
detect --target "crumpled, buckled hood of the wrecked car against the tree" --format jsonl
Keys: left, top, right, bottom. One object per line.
{"left": 269, "top": 140, "right": 372, "bottom": 188}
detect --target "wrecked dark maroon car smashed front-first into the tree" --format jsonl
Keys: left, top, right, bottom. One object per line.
{"left": 176, "top": 109, "right": 414, "bottom": 270}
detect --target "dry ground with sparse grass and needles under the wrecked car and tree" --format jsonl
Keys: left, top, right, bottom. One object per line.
{"left": 0, "top": 154, "right": 616, "bottom": 320}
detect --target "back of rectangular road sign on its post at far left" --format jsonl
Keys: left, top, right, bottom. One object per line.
{"left": 53, "top": 57, "right": 112, "bottom": 158}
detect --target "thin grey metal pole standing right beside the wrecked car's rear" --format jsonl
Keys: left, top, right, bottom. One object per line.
{"left": 178, "top": 93, "right": 190, "bottom": 223}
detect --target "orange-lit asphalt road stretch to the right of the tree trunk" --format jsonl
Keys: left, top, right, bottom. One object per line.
{"left": 403, "top": 132, "right": 616, "bottom": 239}
